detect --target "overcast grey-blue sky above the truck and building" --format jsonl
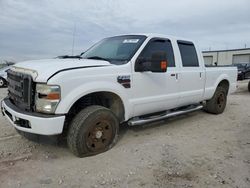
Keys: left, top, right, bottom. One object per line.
{"left": 0, "top": 0, "right": 250, "bottom": 61}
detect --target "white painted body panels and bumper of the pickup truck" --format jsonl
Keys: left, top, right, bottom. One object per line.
{"left": 1, "top": 34, "right": 237, "bottom": 134}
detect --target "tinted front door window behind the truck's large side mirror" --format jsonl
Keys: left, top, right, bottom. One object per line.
{"left": 140, "top": 39, "right": 175, "bottom": 67}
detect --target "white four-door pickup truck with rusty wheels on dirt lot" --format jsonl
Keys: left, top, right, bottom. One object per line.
{"left": 1, "top": 34, "right": 237, "bottom": 157}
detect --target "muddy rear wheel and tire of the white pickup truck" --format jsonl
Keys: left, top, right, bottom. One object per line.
{"left": 204, "top": 86, "right": 227, "bottom": 114}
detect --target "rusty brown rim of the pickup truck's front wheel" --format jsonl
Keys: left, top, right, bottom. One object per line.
{"left": 86, "top": 120, "right": 113, "bottom": 152}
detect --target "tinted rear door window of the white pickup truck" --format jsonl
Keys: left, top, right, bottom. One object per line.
{"left": 178, "top": 41, "right": 199, "bottom": 67}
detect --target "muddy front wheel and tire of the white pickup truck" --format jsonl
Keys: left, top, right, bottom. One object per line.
{"left": 67, "top": 106, "right": 119, "bottom": 157}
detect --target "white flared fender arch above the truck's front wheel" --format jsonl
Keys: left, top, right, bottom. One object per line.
{"left": 56, "top": 81, "right": 129, "bottom": 119}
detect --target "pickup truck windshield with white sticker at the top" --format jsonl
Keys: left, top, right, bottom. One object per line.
{"left": 82, "top": 35, "right": 146, "bottom": 64}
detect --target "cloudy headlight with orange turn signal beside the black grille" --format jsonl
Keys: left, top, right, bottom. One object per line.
{"left": 35, "top": 84, "right": 61, "bottom": 114}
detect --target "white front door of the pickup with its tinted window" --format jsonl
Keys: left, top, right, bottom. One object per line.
{"left": 131, "top": 38, "right": 179, "bottom": 116}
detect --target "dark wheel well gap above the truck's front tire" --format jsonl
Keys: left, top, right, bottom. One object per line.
{"left": 66, "top": 92, "right": 125, "bottom": 128}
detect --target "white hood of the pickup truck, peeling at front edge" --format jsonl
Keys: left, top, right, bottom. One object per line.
{"left": 12, "top": 59, "right": 112, "bottom": 82}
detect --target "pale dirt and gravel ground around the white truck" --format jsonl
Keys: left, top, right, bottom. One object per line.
{"left": 0, "top": 82, "right": 250, "bottom": 188}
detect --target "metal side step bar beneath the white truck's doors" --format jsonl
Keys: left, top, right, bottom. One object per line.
{"left": 128, "top": 105, "right": 203, "bottom": 126}
